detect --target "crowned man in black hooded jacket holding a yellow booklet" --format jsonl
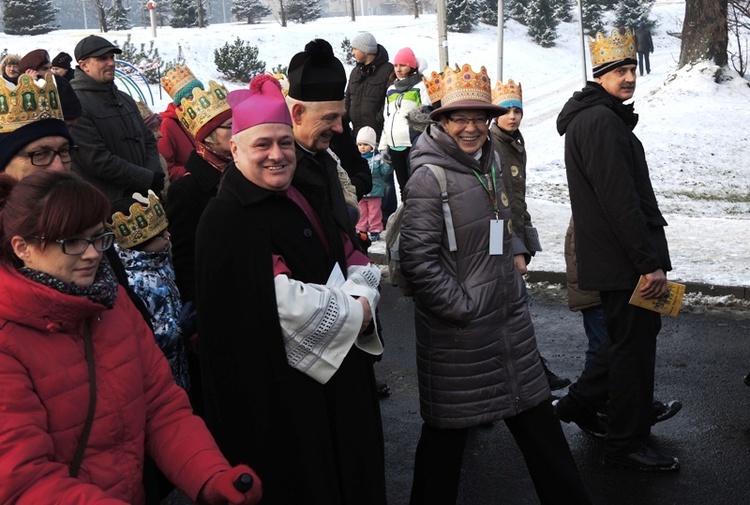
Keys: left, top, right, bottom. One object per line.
{"left": 556, "top": 26, "right": 680, "bottom": 471}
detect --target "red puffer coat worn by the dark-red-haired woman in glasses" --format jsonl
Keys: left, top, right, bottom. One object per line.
{"left": 0, "top": 265, "right": 229, "bottom": 505}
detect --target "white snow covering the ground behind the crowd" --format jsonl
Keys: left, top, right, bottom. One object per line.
{"left": 0, "top": 2, "right": 750, "bottom": 286}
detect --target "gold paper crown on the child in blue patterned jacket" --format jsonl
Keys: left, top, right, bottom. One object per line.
{"left": 107, "top": 189, "right": 169, "bottom": 249}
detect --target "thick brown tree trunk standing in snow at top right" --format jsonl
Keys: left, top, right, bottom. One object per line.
{"left": 679, "top": 0, "right": 729, "bottom": 68}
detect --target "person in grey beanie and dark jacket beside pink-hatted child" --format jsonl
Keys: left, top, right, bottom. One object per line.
{"left": 344, "top": 32, "right": 396, "bottom": 138}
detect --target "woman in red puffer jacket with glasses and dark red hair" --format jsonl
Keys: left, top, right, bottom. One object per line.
{"left": 0, "top": 170, "right": 261, "bottom": 504}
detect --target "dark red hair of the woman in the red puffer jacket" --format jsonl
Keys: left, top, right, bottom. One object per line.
{"left": 0, "top": 172, "right": 109, "bottom": 262}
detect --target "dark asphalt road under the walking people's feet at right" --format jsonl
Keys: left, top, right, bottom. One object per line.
{"left": 376, "top": 287, "right": 750, "bottom": 505}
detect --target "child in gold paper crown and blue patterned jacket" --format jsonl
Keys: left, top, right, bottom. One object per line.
{"left": 107, "top": 190, "right": 192, "bottom": 390}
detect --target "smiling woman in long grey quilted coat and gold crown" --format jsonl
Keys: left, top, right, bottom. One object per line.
{"left": 399, "top": 69, "right": 590, "bottom": 505}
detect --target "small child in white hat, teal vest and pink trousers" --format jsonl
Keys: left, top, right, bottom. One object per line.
{"left": 357, "top": 126, "right": 393, "bottom": 242}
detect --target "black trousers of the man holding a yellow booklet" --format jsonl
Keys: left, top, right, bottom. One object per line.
{"left": 568, "top": 290, "right": 661, "bottom": 455}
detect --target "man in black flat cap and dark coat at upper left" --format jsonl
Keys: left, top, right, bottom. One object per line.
{"left": 70, "top": 35, "right": 165, "bottom": 201}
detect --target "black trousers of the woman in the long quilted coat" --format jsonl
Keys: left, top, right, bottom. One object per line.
{"left": 409, "top": 401, "right": 591, "bottom": 505}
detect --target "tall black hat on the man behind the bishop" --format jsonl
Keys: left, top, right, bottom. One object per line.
{"left": 289, "top": 39, "right": 346, "bottom": 102}
